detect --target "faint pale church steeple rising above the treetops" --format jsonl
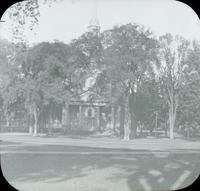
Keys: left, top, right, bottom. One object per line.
{"left": 88, "top": 0, "right": 100, "bottom": 34}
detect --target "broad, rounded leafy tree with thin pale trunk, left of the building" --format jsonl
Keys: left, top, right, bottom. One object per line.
{"left": 14, "top": 43, "right": 79, "bottom": 135}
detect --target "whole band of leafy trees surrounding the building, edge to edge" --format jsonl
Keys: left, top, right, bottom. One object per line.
{"left": 0, "top": 19, "right": 200, "bottom": 138}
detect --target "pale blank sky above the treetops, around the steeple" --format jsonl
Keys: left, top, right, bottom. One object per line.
{"left": 0, "top": 0, "right": 200, "bottom": 44}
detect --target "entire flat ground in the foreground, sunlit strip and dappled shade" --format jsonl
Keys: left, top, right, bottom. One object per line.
{"left": 0, "top": 133, "right": 200, "bottom": 191}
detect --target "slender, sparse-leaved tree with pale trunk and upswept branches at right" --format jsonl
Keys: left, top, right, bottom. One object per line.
{"left": 159, "top": 34, "right": 189, "bottom": 139}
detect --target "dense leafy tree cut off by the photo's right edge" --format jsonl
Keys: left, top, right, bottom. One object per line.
{"left": 179, "top": 41, "right": 200, "bottom": 131}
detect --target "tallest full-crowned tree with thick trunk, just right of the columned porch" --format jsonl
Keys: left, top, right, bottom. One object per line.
{"left": 98, "top": 24, "right": 157, "bottom": 138}
